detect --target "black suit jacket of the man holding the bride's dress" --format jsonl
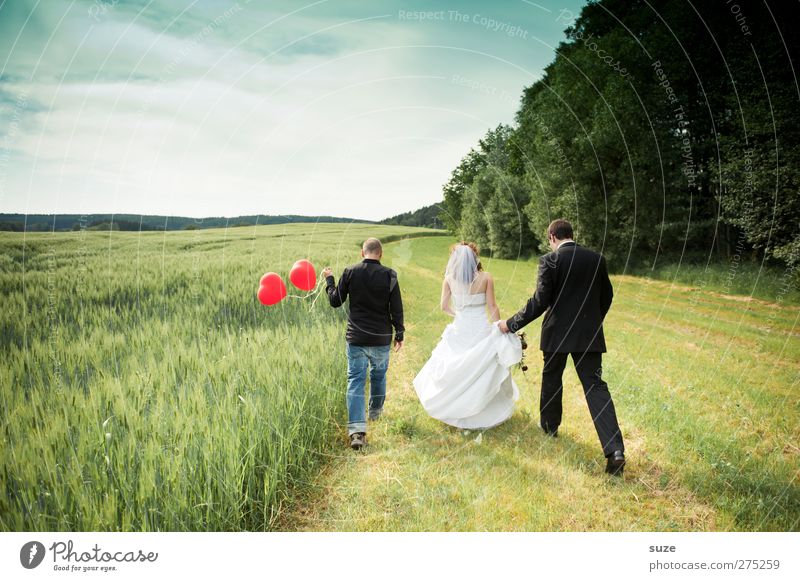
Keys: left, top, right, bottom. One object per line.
{"left": 506, "top": 241, "right": 614, "bottom": 353}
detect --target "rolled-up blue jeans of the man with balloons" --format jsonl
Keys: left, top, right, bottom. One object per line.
{"left": 347, "top": 343, "right": 391, "bottom": 434}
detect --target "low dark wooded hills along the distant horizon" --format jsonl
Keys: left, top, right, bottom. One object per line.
{"left": 0, "top": 204, "right": 442, "bottom": 232}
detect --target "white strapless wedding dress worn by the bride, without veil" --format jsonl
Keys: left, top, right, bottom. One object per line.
{"left": 414, "top": 293, "right": 522, "bottom": 429}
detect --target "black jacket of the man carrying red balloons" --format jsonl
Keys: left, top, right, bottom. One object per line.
{"left": 326, "top": 258, "right": 405, "bottom": 345}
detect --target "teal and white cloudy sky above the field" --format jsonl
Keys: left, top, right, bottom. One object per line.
{"left": 0, "top": 0, "right": 583, "bottom": 220}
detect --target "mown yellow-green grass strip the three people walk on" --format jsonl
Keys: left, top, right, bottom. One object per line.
{"left": 281, "top": 238, "right": 800, "bottom": 531}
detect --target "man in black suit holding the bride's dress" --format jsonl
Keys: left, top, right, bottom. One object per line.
{"left": 500, "top": 220, "right": 625, "bottom": 476}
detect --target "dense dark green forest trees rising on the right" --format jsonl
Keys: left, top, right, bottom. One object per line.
{"left": 441, "top": 0, "right": 800, "bottom": 269}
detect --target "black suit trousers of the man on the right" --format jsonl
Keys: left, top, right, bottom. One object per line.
{"left": 539, "top": 351, "right": 625, "bottom": 457}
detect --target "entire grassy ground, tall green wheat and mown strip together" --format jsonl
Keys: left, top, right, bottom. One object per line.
{"left": 0, "top": 224, "right": 800, "bottom": 531}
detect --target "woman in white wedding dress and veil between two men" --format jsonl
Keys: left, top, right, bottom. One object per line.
{"left": 414, "top": 242, "right": 522, "bottom": 429}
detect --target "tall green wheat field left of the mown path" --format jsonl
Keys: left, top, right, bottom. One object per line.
{"left": 0, "top": 224, "right": 438, "bottom": 531}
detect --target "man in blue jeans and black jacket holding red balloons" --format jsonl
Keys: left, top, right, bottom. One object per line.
{"left": 322, "top": 238, "right": 405, "bottom": 450}
